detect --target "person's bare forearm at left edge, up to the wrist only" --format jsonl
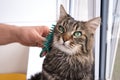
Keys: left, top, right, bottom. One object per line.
{"left": 0, "top": 24, "right": 18, "bottom": 45}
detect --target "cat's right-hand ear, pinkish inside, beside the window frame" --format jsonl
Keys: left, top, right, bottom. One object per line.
{"left": 85, "top": 17, "right": 101, "bottom": 33}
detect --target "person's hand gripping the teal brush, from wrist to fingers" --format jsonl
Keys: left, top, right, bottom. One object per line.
{"left": 17, "top": 26, "right": 49, "bottom": 47}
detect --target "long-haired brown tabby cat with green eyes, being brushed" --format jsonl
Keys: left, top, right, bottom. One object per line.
{"left": 30, "top": 5, "right": 101, "bottom": 80}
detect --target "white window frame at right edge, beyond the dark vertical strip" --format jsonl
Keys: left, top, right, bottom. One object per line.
{"left": 106, "top": 0, "right": 120, "bottom": 80}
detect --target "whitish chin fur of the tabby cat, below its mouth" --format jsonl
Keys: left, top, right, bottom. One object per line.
{"left": 54, "top": 44, "right": 78, "bottom": 55}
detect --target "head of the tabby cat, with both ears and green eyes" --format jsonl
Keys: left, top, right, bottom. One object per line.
{"left": 53, "top": 5, "right": 101, "bottom": 55}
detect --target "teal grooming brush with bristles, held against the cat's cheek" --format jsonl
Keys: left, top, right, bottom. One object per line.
{"left": 40, "top": 25, "right": 55, "bottom": 57}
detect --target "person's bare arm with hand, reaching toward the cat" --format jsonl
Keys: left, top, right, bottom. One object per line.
{"left": 0, "top": 24, "right": 49, "bottom": 47}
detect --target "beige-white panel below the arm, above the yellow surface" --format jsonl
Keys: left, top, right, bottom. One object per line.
{"left": 0, "top": 43, "right": 28, "bottom": 73}
